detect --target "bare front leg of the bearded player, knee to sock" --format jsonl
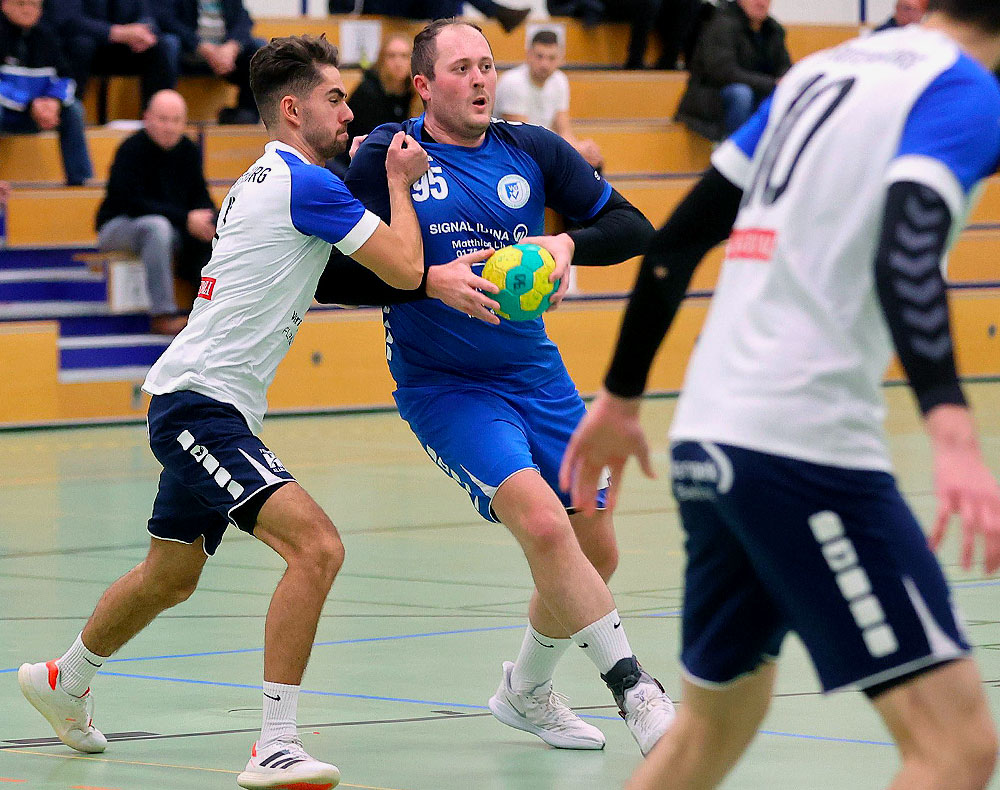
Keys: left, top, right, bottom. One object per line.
{"left": 254, "top": 483, "right": 344, "bottom": 686}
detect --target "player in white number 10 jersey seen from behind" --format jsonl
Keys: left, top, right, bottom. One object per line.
{"left": 560, "top": 0, "right": 1000, "bottom": 790}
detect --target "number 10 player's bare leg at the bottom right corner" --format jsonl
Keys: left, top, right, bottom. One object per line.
{"left": 874, "top": 659, "right": 997, "bottom": 790}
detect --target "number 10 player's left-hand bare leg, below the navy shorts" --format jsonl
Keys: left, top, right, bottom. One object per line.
{"left": 625, "top": 664, "right": 775, "bottom": 790}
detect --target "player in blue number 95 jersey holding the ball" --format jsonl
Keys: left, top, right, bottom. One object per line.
{"left": 318, "top": 20, "right": 674, "bottom": 753}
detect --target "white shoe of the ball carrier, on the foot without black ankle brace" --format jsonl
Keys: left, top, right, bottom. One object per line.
{"left": 489, "top": 661, "right": 604, "bottom": 749}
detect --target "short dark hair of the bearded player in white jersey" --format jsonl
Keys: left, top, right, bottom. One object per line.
{"left": 250, "top": 33, "right": 340, "bottom": 126}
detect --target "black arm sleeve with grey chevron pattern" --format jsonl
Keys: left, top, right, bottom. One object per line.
{"left": 875, "top": 181, "right": 965, "bottom": 414}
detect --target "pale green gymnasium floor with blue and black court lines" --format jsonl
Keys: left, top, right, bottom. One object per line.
{"left": 0, "top": 384, "right": 1000, "bottom": 790}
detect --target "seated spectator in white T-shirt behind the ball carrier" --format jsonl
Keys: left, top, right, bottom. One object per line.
{"left": 494, "top": 30, "right": 604, "bottom": 170}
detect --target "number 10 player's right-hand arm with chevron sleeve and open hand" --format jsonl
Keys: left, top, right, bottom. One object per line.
{"left": 875, "top": 182, "right": 1000, "bottom": 573}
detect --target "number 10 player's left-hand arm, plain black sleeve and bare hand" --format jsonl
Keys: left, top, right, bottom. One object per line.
{"left": 559, "top": 168, "right": 743, "bottom": 513}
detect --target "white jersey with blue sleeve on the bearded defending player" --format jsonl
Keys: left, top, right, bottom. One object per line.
{"left": 143, "top": 142, "right": 379, "bottom": 433}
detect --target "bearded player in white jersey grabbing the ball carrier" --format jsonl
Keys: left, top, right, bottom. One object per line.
{"left": 18, "top": 36, "right": 427, "bottom": 790}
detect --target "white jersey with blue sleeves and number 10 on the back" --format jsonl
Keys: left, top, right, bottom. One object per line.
{"left": 671, "top": 26, "right": 1000, "bottom": 471}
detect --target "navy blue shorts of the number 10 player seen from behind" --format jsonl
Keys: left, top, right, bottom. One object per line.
{"left": 672, "top": 442, "right": 969, "bottom": 691}
